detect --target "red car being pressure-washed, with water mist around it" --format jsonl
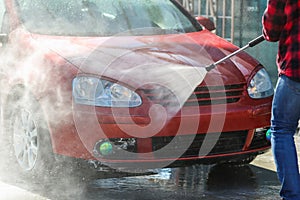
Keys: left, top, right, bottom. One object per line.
{"left": 0, "top": 0, "right": 273, "bottom": 174}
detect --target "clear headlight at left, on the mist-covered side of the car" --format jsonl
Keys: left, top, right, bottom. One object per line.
{"left": 72, "top": 76, "right": 142, "bottom": 107}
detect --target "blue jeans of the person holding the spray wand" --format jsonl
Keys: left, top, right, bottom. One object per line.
{"left": 271, "top": 75, "right": 300, "bottom": 200}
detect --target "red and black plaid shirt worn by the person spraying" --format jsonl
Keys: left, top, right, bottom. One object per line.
{"left": 262, "top": 0, "right": 300, "bottom": 81}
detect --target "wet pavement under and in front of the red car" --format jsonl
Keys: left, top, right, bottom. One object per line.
{"left": 0, "top": 137, "right": 299, "bottom": 200}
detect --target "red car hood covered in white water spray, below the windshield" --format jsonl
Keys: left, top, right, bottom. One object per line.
{"left": 31, "top": 31, "right": 259, "bottom": 104}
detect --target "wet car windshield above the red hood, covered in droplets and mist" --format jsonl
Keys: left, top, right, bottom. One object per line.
{"left": 16, "top": 0, "right": 201, "bottom": 36}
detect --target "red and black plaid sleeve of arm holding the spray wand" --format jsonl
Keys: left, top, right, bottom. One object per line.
{"left": 262, "top": 0, "right": 286, "bottom": 42}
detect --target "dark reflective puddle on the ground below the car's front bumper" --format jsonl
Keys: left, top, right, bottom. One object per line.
{"left": 84, "top": 165, "right": 279, "bottom": 200}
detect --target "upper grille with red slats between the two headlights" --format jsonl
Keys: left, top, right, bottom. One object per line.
{"left": 143, "top": 83, "right": 245, "bottom": 106}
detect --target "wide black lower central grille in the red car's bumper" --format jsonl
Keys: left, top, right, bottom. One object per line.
{"left": 152, "top": 131, "right": 248, "bottom": 158}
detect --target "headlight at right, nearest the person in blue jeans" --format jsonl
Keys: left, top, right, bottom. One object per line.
{"left": 248, "top": 68, "right": 274, "bottom": 99}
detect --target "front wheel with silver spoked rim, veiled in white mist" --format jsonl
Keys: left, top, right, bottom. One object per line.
{"left": 5, "top": 88, "right": 54, "bottom": 179}
